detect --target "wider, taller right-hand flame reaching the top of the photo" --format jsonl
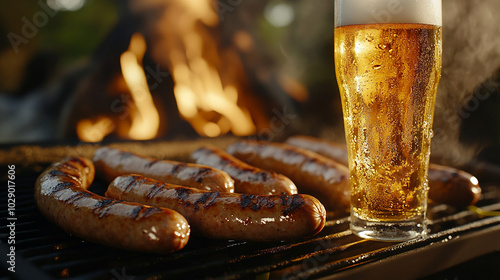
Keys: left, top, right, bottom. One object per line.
{"left": 167, "top": 0, "right": 256, "bottom": 137}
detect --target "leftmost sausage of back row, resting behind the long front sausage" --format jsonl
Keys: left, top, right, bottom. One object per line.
{"left": 93, "top": 147, "right": 234, "bottom": 192}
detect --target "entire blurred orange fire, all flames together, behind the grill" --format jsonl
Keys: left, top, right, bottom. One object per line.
{"left": 77, "top": 0, "right": 307, "bottom": 142}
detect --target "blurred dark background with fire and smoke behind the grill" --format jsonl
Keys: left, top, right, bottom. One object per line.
{"left": 0, "top": 0, "right": 500, "bottom": 168}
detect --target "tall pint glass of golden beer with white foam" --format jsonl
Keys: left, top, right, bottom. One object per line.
{"left": 335, "top": 0, "right": 442, "bottom": 241}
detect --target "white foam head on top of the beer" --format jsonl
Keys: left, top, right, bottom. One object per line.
{"left": 335, "top": 0, "right": 442, "bottom": 26}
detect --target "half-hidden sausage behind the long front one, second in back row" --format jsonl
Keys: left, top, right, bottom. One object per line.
{"left": 191, "top": 146, "right": 297, "bottom": 195}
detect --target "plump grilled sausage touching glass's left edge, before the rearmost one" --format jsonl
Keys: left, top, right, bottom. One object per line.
{"left": 228, "top": 140, "right": 350, "bottom": 210}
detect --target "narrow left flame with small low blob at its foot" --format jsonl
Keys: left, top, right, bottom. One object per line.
{"left": 76, "top": 33, "right": 160, "bottom": 142}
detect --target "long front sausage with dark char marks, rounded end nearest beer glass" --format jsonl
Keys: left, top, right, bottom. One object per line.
{"left": 106, "top": 175, "right": 326, "bottom": 241}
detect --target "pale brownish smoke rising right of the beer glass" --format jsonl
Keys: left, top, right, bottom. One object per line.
{"left": 432, "top": 0, "right": 500, "bottom": 165}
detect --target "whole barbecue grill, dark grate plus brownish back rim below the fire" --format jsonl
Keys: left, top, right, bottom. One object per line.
{"left": 0, "top": 140, "right": 500, "bottom": 280}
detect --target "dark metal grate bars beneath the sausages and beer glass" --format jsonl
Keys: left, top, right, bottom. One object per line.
{"left": 0, "top": 154, "right": 500, "bottom": 280}
